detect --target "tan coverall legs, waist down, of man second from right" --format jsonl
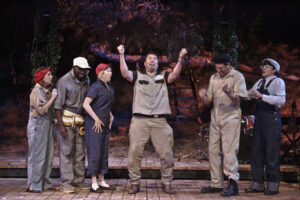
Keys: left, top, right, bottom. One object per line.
{"left": 208, "top": 118, "right": 241, "bottom": 188}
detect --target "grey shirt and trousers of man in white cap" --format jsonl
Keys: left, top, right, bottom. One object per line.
{"left": 54, "top": 69, "right": 89, "bottom": 186}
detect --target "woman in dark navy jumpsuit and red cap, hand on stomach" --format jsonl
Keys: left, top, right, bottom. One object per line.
{"left": 83, "top": 63, "right": 115, "bottom": 193}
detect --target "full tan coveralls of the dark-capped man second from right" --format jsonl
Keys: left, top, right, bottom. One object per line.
{"left": 207, "top": 69, "right": 247, "bottom": 188}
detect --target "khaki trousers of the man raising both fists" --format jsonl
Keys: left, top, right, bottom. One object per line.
{"left": 128, "top": 116, "right": 174, "bottom": 184}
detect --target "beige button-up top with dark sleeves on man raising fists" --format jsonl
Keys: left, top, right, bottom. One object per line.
{"left": 132, "top": 71, "right": 171, "bottom": 115}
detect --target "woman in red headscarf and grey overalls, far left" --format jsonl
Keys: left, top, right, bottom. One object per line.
{"left": 27, "top": 67, "right": 57, "bottom": 193}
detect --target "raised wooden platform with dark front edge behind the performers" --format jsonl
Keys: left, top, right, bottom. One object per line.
{"left": 0, "top": 151, "right": 300, "bottom": 182}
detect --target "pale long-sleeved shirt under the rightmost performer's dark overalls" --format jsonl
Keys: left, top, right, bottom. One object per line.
{"left": 248, "top": 76, "right": 286, "bottom": 108}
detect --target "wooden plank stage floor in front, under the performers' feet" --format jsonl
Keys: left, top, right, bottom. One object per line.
{"left": 0, "top": 178, "right": 300, "bottom": 200}
